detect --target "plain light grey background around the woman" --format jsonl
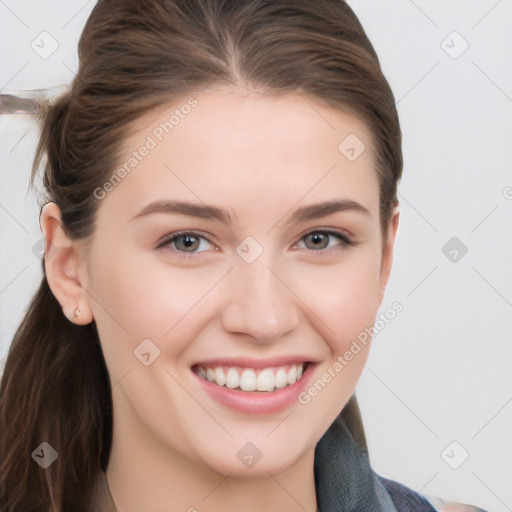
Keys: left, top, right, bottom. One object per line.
{"left": 0, "top": 0, "right": 512, "bottom": 512}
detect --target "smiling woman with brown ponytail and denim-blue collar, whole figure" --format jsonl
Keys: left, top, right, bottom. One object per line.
{"left": 0, "top": 0, "right": 486, "bottom": 512}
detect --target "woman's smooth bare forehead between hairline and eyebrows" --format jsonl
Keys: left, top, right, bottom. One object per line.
{"left": 103, "top": 88, "right": 378, "bottom": 222}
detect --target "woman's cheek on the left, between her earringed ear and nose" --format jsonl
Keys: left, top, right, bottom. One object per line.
{"left": 88, "top": 246, "right": 225, "bottom": 362}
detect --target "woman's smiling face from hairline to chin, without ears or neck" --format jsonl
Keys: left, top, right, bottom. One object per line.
{"left": 74, "top": 89, "right": 396, "bottom": 476}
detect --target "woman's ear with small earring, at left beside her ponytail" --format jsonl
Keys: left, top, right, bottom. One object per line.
{"left": 39, "top": 202, "right": 93, "bottom": 325}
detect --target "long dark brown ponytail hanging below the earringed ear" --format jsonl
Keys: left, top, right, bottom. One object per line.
{"left": 0, "top": 267, "right": 112, "bottom": 512}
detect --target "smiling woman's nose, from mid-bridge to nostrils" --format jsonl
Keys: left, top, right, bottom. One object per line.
{"left": 222, "top": 257, "right": 299, "bottom": 343}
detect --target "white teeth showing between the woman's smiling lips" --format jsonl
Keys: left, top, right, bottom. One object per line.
{"left": 192, "top": 363, "right": 308, "bottom": 393}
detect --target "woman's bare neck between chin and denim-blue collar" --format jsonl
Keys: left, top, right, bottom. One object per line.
{"left": 106, "top": 390, "right": 317, "bottom": 512}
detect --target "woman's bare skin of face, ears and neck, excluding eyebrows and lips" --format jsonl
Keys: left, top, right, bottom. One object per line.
{"left": 41, "top": 89, "right": 399, "bottom": 512}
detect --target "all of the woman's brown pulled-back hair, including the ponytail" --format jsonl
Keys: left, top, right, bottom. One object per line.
{"left": 0, "top": 0, "right": 402, "bottom": 512}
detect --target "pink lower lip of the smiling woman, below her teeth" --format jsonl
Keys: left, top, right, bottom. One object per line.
{"left": 192, "top": 363, "right": 315, "bottom": 414}
